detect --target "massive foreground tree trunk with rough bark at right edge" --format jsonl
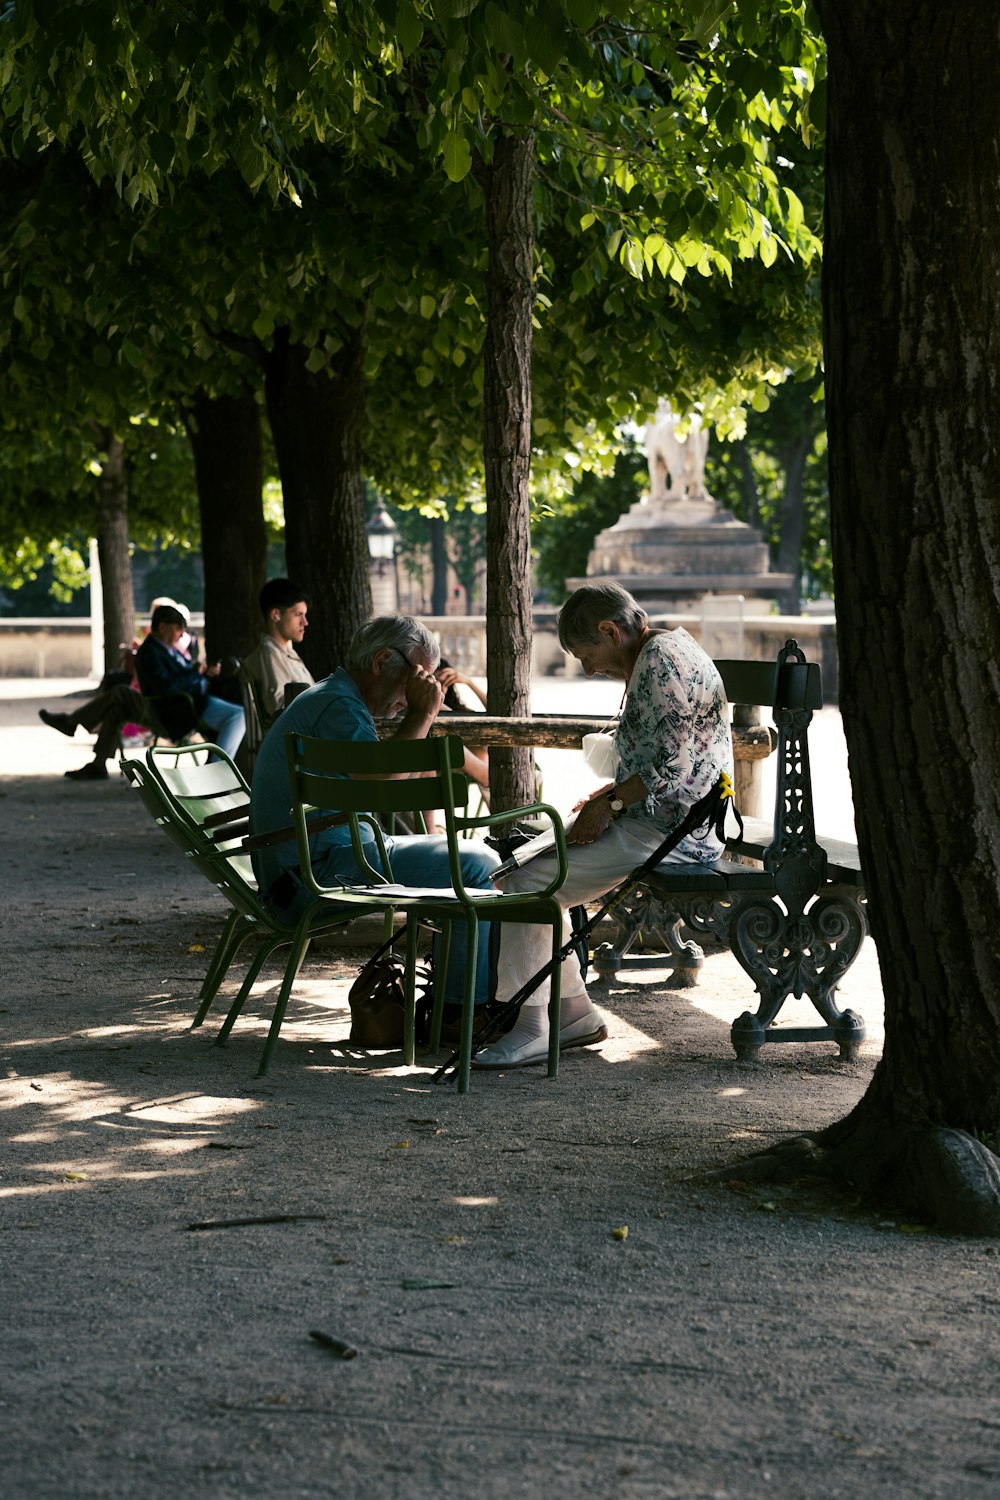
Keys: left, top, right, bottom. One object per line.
{"left": 773, "top": 0, "right": 1000, "bottom": 1233}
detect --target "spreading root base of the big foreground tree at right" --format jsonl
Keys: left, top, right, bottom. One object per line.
{"left": 709, "top": 1116, "right": 1000, "bottom": 1236}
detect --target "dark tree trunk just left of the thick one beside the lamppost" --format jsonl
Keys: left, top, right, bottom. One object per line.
{"left": 186, "top": 387, "right": 267, "bottom": 662}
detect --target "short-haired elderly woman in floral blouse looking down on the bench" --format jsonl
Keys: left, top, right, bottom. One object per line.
{"left": 474, "top": 584, "right": 733, "bottom": 1068}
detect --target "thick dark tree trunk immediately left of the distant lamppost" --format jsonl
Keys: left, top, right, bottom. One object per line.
{"left": 264, "top": 327, "right": 372, "bottom": 678}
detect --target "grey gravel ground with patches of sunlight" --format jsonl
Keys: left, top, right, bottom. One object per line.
{"left": 0, "top": 684, "right": 1000, "bottom": 1500}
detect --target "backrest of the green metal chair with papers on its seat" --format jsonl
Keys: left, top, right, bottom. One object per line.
{"left": 285, "top": 734, "right": 479, "bottom": 897}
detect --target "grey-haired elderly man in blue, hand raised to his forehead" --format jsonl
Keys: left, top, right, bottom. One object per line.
{"left": 250, "top": 615, "right": 501, "bottom": 1020}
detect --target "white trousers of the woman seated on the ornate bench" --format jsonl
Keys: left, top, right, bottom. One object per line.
{"left": 496, "top": 818, "right": 688, "bottom": 1005}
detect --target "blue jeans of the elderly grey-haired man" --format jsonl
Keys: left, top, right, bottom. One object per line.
{"left": 308, "top": 834, "right": 501, "bottom": 1005}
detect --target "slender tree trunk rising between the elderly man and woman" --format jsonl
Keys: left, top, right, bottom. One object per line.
{"left": 483, "top": 134, "right": 535, "bottom": 812}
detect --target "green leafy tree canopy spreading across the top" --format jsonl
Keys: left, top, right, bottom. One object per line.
{"left": 0, "top": 0, "right": 825, "bottom": 591}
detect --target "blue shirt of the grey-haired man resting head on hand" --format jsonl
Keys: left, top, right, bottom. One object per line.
{"left": 250, "top": 668, "right": 378, "bottom": 893}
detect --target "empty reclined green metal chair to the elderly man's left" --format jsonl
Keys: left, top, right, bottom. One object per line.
{"left": 121, "top": 744, "right": 355, "bottom": 1073}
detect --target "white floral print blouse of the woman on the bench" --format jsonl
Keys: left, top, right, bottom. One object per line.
{"left": 615, "top": 630, "right": 733, "bottom": 864}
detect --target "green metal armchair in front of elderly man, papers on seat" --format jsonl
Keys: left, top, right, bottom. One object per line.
{"left": 285, "top": 734, "right": 567, "bottom": 1094}
